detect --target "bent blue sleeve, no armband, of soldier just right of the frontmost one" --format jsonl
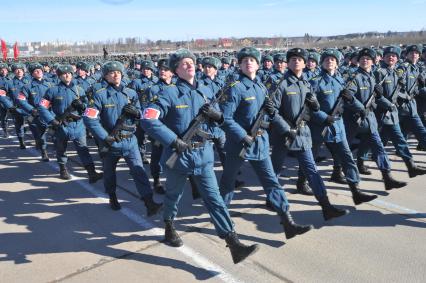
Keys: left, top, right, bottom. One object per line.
{"left": 220, "top": 86, "right": 247, "bottom": 141}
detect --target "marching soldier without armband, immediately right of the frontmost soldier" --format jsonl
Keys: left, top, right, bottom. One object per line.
{"left": 220, "top": 47, "right": 312, "bottom": 239}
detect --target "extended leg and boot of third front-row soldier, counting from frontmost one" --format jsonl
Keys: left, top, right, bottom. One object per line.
{"left": 296, "top": 149, "right": 349, "bottom": 220}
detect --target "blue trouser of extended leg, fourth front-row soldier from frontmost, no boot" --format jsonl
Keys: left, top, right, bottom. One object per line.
{"left": 325, "top": 139, "right": 360, "bottom": 184}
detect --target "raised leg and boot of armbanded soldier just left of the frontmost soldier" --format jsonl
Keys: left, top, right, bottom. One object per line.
{"left": 122, "top": 137, "right": 162, "bottom": 216}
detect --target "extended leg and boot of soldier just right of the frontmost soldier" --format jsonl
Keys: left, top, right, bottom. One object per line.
{"left": 250, "top": 157, "right": 313, "bottom": 239}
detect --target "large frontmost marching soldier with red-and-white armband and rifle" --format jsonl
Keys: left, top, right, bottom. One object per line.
{"left": 142, "top": 49, "right": 257, "bottom": 263}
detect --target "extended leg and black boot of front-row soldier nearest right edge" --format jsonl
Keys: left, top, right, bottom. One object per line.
{"left": 381, "top": 124, "right": 426, "bottom": 178}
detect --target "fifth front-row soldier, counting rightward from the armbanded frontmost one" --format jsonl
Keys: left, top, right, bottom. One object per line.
{"left": 341, "top": 48, "right": 407, "bottom": 190}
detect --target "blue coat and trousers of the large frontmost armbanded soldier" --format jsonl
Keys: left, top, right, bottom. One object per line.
{"left": 141, "top": 78, "right": 233, "bottom": 238}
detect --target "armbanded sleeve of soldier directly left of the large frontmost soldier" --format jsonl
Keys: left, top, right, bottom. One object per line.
{"left": 83, "top": 92, "right": 108, "bottom": 141}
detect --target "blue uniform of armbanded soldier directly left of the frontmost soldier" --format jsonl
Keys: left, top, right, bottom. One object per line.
{"left": 83, "top": 81, "right": 152, "bottom": 198}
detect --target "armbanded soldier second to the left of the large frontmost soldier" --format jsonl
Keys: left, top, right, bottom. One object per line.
{"left": 37, "top": 65, "right": 102, "bottom": 183}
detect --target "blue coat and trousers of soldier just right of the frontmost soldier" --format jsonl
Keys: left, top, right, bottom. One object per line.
{"left": 220, "top": 74, "right": 289, "bottom": 215}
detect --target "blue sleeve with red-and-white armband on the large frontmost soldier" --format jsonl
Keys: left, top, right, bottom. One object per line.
{"left": 140, "top": 93, "right": 177, "bottom": 147}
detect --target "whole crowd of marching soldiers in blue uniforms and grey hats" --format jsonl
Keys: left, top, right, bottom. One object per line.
{"left": 0, "top": 45, "right": 426, "bottom": 263}
